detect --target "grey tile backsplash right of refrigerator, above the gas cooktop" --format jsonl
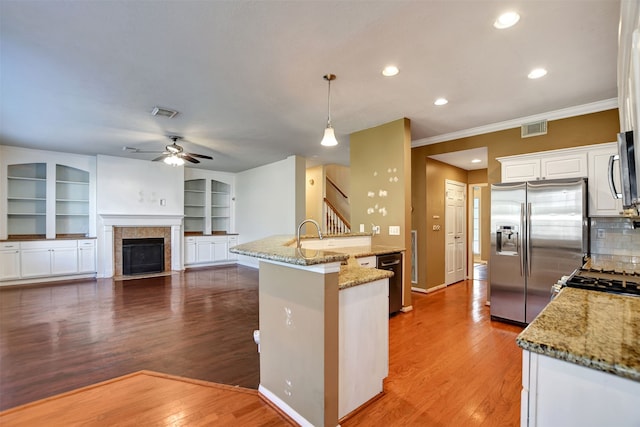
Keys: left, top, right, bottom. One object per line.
{"left": 591, "top": 217, "right": 640, "bottom": 258}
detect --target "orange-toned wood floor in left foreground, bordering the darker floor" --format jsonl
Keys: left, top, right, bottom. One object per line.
{"left": 0, "top": 371, "right": 296, "bottom": 427}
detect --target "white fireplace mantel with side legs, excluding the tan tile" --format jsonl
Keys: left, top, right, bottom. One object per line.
{"left": 98, "top": 214, "right": 183, "bottom": 277}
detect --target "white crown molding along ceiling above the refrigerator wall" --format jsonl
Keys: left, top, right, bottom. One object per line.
{"left": 411, "top": 98, "right": 618, "bottom": 148}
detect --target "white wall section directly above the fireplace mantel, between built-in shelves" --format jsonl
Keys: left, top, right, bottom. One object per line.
{"left": 97, "top": 155, "right": 184, "bottom": 215}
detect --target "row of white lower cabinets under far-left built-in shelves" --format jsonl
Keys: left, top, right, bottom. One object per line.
{"left": 0, "top": 239, "right": 96, "bottom": 285}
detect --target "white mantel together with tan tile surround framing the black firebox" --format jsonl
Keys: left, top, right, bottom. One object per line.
{"left": 98, "top": 214, "right": 182, "bottom": 277}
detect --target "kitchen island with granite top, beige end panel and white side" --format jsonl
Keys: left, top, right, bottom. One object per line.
{"left": 231, "top": 236, "right": 392, "bottom": 427}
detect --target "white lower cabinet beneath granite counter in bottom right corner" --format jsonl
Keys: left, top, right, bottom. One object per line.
{"left": 520, "top": 350, "right": 640, "bottom": 427}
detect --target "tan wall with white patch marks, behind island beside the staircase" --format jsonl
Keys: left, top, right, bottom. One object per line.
{"left": 349, "top": 118, "right": 411, "bottom": 306}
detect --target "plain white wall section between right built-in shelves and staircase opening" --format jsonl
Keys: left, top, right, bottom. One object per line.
{"left": 236, "top": 156, "right": 305, "bottom": 267}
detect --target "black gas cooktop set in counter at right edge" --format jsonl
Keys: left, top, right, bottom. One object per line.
{"left": 562, "top": 269, "right": 640, "bottom": 296}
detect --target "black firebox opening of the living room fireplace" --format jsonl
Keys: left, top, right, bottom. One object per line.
{"left": 122, "top": 237, "right": 164, "bottom": 276}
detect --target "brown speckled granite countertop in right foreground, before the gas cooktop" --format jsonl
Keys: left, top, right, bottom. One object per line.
{"left": 516, "top": 288, "right": 640, "bottom": 381}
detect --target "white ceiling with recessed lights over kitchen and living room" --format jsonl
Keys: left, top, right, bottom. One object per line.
{"left": 0, "top": 0, "right": 619, "bottom": 172}
